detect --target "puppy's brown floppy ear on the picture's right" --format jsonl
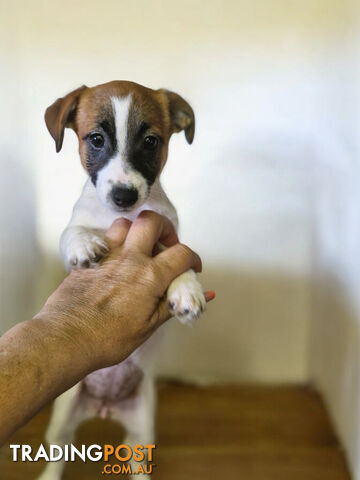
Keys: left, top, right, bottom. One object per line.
{"left": 160, "top": 88, "right": 195, "bottom": 143}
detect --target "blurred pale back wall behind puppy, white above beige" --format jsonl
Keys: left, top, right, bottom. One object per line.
{"left": 0, "top": 0, "right": 357, "bottom": 472}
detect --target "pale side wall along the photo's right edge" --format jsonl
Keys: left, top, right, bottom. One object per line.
{"left": 309, "top": 15, "right": 360, "bottom": 480}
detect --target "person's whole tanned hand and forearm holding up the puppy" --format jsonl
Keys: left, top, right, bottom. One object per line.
{"left": 0, "top": 211, "right": 214, "bottom": 444}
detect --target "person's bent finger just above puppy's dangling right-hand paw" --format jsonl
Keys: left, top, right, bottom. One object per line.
{"left": 153, "top": 243, "right": 202, "bottom": 286}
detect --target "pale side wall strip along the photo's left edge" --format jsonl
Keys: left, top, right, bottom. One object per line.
{"left": 0, "top": 16, "right": 38, "bottom": 333}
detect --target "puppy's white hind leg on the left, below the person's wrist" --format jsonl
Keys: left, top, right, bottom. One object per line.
{"left": 37, "top": 383, "right": 87, "bottom": 480}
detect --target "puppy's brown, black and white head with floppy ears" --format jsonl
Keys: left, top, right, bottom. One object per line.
{"left": 45, "top": 81, "right": 195, "bottom": 211}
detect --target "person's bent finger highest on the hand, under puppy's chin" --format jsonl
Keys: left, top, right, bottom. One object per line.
{"left": 125, "top": 210, "right": 178, "bottom": 255}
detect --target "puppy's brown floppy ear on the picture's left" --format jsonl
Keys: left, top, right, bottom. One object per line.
{"left": 45, "top": 85, "right": 87, "bottom": 152}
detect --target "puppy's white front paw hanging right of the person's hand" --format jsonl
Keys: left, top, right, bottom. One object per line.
{"left": 167, "top": 270, "right": 206, "bottom": 324}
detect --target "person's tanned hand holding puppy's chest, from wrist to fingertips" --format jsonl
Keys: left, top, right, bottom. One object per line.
{"left": 38, "top": 211, "right": 214, "bottom": 370}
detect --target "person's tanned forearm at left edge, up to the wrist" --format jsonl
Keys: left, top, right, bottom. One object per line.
{"left": 0, "top": 314, "right": 92, "bottom": 444}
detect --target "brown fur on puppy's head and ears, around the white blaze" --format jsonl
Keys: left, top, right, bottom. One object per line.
{"left": 45, "top": 81, "right": 195, "bottom": 184}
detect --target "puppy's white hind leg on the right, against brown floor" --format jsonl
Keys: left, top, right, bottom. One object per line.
{"left": 112, "top": 375, "right": 156, "bottom": 480}
